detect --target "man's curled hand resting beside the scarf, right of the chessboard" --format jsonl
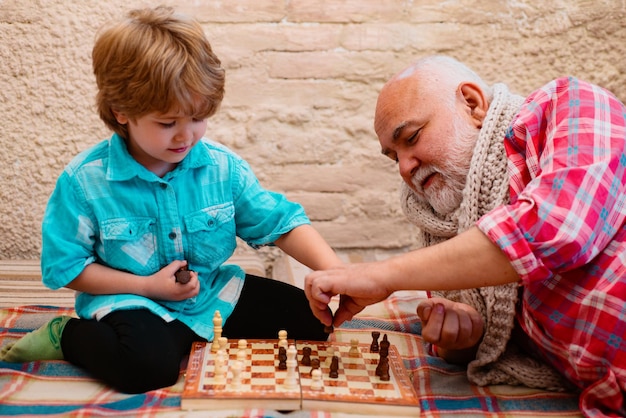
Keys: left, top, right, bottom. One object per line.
{"left": 417, "top": 298, "right": 483, "bottom": 363}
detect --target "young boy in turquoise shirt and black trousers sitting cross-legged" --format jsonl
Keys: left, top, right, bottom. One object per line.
{"left": 0, "top": 7, "right": 341, "bottom": 393}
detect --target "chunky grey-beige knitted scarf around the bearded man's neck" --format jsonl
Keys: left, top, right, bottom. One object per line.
{"left": 401, "top": 84, "right": 564, "bottom": 390}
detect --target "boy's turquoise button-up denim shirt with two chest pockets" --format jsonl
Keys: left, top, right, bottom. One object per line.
{"left": 41, "top": 134, "right": 310, "bottom": 340}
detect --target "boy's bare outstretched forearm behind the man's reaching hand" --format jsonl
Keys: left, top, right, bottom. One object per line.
{"left": 275, "top": 225, "right": 343, "bottom": 270}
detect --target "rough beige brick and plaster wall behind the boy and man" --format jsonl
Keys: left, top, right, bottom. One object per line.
{"left": 0, "top": 0, "right": 626, "bottom": 258}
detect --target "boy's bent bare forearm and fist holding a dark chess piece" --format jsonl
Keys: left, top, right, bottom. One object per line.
{"left": 66, "top": 260, "right": 200, "bottom": 301}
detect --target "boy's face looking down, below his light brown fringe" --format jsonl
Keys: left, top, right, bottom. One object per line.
{"left": 114, "top": 108, "right": 207, "bottom": 177}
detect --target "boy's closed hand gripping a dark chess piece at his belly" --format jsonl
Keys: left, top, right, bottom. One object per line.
{"left": 147, "top": 260, "right": 200, "bottom": 301}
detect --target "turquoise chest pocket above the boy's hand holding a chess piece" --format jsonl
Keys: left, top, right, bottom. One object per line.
{"left": 100, "top": 218, "right": 159, "bottom": 276}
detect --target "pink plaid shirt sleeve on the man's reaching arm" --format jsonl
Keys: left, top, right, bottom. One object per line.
{"left": 478, "top": 78, "right": 626, "bottom": 282}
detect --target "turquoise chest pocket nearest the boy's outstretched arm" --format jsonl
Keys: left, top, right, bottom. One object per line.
{"left": 183, "top": 203, "right": 237, "bottom": 270}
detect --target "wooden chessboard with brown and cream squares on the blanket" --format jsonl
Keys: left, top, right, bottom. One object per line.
{"left": 181, "top": 340, "right": 419, "bottom": 416}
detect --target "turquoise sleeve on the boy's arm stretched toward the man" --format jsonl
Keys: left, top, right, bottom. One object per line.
{"left": 228, "top": 160, "right": 310, "bottom": 248}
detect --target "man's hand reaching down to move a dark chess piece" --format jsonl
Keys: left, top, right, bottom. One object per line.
{"left": 304, "top": 263, "right": 392, "bottom": 326}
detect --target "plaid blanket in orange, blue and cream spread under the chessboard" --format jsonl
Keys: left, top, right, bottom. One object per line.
{"left": 0, "top": 292, "right": 581, "bottom": 418}
